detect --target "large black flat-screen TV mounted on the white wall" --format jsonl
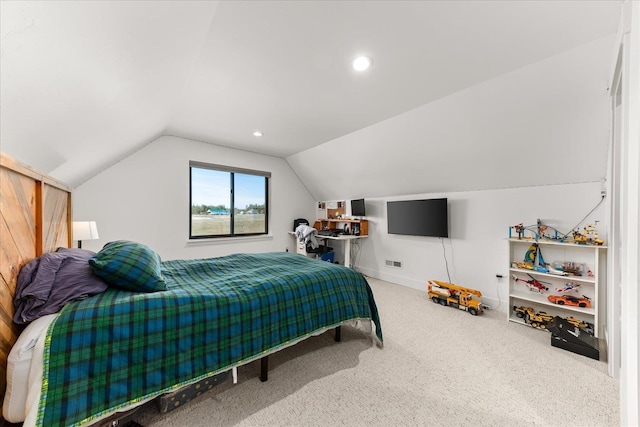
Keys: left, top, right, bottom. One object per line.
{"left": 387, "top": 198, "right": 449, "bottom": 237}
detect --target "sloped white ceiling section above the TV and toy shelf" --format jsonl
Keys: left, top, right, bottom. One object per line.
{"left": 287, "top": 35, "right": 615, "bottom": 200}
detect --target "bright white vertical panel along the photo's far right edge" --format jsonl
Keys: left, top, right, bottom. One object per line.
{"left": 613, "top": 1, "right": 640, "bottom": 426}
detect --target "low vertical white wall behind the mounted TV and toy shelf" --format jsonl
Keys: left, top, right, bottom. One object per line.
{"left": 356, "top": 182, "right": 607, "bottom": 312}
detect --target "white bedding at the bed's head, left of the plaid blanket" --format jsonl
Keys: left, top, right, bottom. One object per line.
{"left": 2, "top": 313, "right": 58, "bottom": 423}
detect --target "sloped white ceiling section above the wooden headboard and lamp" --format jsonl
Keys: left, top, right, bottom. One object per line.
{"left": 0, "top": 1, "right": 216, "bottom": 186}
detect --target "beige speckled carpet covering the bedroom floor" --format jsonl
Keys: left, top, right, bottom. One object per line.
{"left": 134, "top": 279, "right": 620, "bottom": 427}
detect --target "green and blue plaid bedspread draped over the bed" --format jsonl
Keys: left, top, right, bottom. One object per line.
{"left": 37, "top": 252, "right": 382, "bottom": 426}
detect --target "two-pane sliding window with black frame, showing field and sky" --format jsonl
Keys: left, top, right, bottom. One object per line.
{"left": 189, "top": 161, "right": 271, "bottom": 239}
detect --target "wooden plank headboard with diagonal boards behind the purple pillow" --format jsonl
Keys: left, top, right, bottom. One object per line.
{"left": 0, "top": 153, "right": 72, "bottom": 416}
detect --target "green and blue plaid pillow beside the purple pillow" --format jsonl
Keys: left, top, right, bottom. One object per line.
{"left": 89, "top": 240, "right": 167, "bottom": 292}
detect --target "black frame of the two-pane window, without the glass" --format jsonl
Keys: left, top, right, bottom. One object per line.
{"left": 189, "top": 160, "right": 271, "bottom": 240}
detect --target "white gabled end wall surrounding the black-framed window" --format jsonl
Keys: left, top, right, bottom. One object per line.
{"left": 73, "top": 136, "right": 315, "bottom": 260}
